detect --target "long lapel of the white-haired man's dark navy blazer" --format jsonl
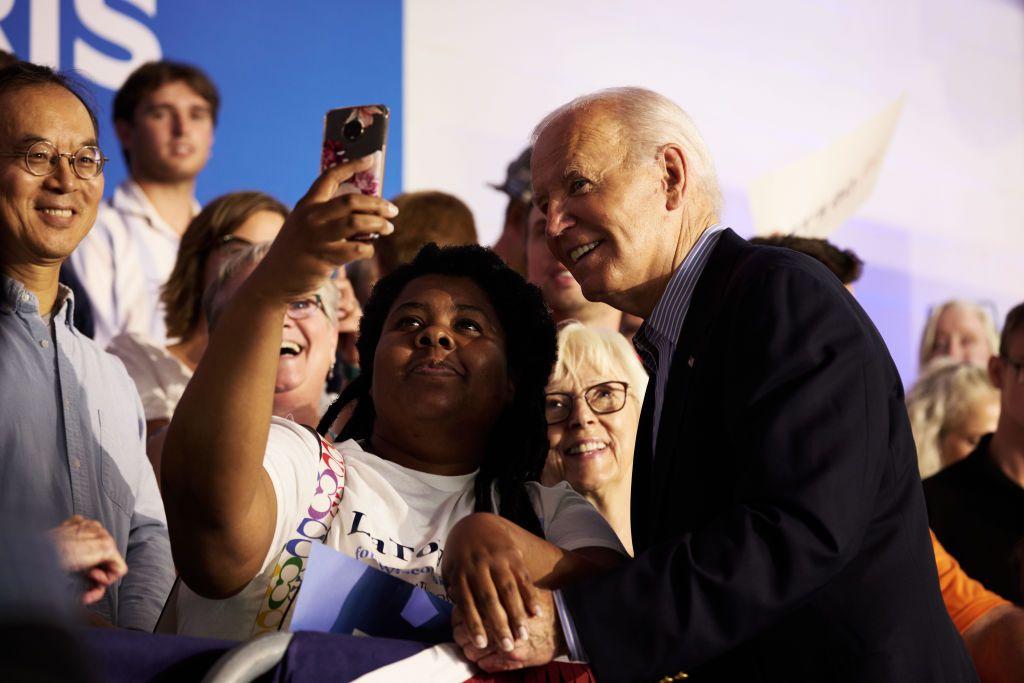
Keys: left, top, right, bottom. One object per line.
{"left": 651, "top": 228, "right": 746, "bottom": 523}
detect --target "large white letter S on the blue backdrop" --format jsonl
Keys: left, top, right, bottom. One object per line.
{"left": 75, "top": 0, "right": 162, "bottom": 90}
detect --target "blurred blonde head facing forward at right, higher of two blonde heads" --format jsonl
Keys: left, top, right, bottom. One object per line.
{"left": 919, "top": 300, "right": 999, "bottom": 370}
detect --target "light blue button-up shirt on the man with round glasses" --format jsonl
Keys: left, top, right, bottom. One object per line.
{"left": 0, "top": 274, "right": 174, "bottom": 631}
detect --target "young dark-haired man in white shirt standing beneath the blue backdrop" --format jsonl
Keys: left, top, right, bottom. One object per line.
{"left": 72, "top": 61, "right": 220, "bottom": 346}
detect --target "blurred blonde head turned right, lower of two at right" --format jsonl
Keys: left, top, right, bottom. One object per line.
{"left": 906, "top": 358, "right": 999, "bottom": 478}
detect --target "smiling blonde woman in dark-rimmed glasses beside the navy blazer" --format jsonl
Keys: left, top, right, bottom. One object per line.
{"left": 541, "top": 322, "right": 647, "bottom": 555}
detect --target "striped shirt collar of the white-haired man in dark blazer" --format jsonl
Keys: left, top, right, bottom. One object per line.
{"left": 634, "top": 223, "right": 726, "bottom": 350}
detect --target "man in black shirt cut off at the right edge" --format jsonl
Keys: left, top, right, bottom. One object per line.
{"left": 925, "top": 303, "right": 1024, "bottom": 605}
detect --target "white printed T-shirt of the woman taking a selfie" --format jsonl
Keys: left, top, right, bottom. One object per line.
{"left": 176, "top": 418, "right": 626, "bottom": 640}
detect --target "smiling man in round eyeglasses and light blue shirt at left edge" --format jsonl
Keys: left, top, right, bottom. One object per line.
{"left": 0, "top": 62, "right": 173, "bottom": 630}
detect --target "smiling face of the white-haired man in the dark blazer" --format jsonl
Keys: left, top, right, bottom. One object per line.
{"left": 532, "top": 109, "right": 679, "bottom": 310}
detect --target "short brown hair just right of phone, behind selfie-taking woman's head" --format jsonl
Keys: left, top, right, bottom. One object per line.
{"left": 376, "top": 191, "right": 477, "bottom": 278}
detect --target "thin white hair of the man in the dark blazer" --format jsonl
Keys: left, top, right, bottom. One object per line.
{"left": 531, "top": 87, "right": 722, "bottom": 220}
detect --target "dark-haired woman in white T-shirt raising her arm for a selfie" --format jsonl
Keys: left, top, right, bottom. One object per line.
{"left": 163, "top": 157, "right": 623, "bottom": 650}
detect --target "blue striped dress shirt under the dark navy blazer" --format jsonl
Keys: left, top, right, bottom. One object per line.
{"left": 633, "top": 223, "right": 726, "bottom": 450}
